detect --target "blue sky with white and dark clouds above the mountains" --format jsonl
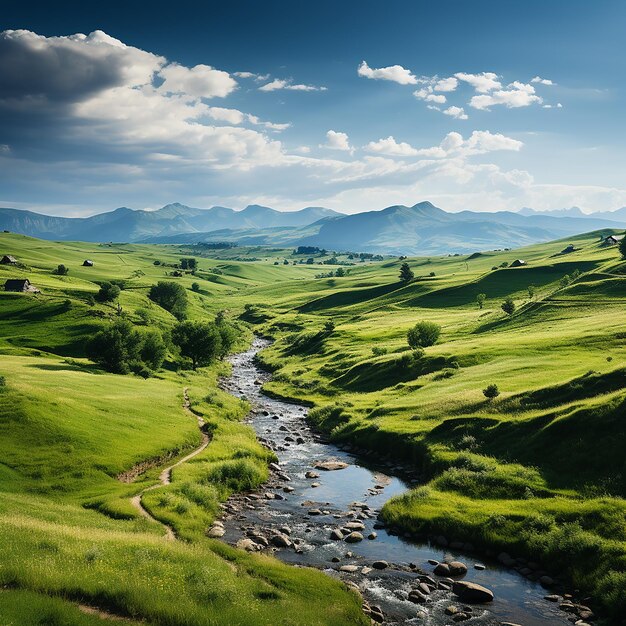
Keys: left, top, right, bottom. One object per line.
{"left": 0, "top": 0, "right": 626, "bottom": 216}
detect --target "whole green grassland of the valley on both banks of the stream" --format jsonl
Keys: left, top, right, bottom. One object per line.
{"left": 0, "top": 233, "right": 626, "bottom": 624}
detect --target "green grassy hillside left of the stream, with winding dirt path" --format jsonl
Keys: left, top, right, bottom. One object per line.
{"left": 0, "top": 234, "right": 365, "bottom": 626}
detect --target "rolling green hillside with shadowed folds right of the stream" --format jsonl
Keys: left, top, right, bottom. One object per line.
{"left": 225, "top": 234, "right": 626, "bottom": 614}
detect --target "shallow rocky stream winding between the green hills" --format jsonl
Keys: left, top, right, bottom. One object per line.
{"left": 222, "top": 339, "right": 571, "bottom": 626}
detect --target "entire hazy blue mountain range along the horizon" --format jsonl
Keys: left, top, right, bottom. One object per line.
{"left": 0, "top": 202, "right": 626, "bottom": 254}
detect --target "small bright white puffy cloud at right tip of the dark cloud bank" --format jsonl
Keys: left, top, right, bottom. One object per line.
{"left": 159, "top": 63, "right": 237, "bottom": 98}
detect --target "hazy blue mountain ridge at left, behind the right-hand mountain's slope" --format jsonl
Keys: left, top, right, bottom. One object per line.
{"left": 0, "top": 202, "right": 342, "bottom": 242}
